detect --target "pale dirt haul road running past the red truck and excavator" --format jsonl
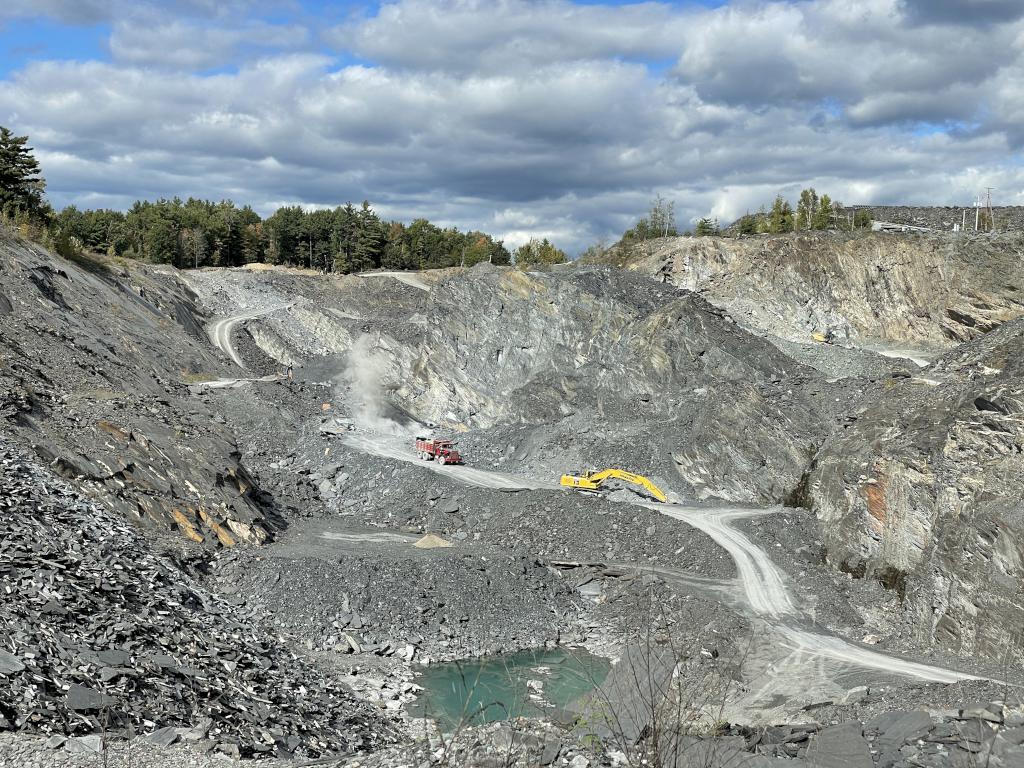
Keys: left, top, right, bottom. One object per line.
{"left": 345, "top": 434, "right": 983, "bottom": 715}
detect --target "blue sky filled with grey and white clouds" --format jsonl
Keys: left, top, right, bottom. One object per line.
{"left": 0, "top": 0, "right": 1024, "bottom": 253}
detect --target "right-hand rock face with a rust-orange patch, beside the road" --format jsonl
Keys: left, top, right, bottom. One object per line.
{"left": 803, "top": 319, "right": 1024, "bottom": 656}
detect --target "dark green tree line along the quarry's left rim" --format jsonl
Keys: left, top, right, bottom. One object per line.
{"left": 0, "top": 127, "right": 567, "bottom": 272}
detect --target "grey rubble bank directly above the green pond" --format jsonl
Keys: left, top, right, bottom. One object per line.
{"left": 215, "top": 545, "right": 584, "bottom": 660}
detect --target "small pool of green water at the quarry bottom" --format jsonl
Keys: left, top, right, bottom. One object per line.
{"left": 409, "top": 648, "right": 611, "bottom": 728}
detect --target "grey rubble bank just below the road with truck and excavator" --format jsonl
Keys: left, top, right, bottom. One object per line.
{"left": 309, "top": 437, "right": 734, "bottom": 579}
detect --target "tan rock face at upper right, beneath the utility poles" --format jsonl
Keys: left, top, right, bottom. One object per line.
{"left": 629, "top": 233, "right": 1024, "bottom": 347}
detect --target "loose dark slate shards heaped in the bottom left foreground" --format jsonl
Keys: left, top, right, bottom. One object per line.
{"left": 0, "top": 439, "right": 393, "bottom": 757}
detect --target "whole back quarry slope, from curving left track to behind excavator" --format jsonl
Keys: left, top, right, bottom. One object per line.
{"left": 188, "top": 265, "right": 845, "bottom": 502}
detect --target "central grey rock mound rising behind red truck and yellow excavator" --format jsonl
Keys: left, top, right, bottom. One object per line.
{"left": 393, "top": 268, "right": 835, "bottom": 502}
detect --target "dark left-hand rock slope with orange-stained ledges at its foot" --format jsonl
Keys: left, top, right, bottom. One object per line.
{"left": 0, "top": 236, "right": 270, "bottom": 546}
